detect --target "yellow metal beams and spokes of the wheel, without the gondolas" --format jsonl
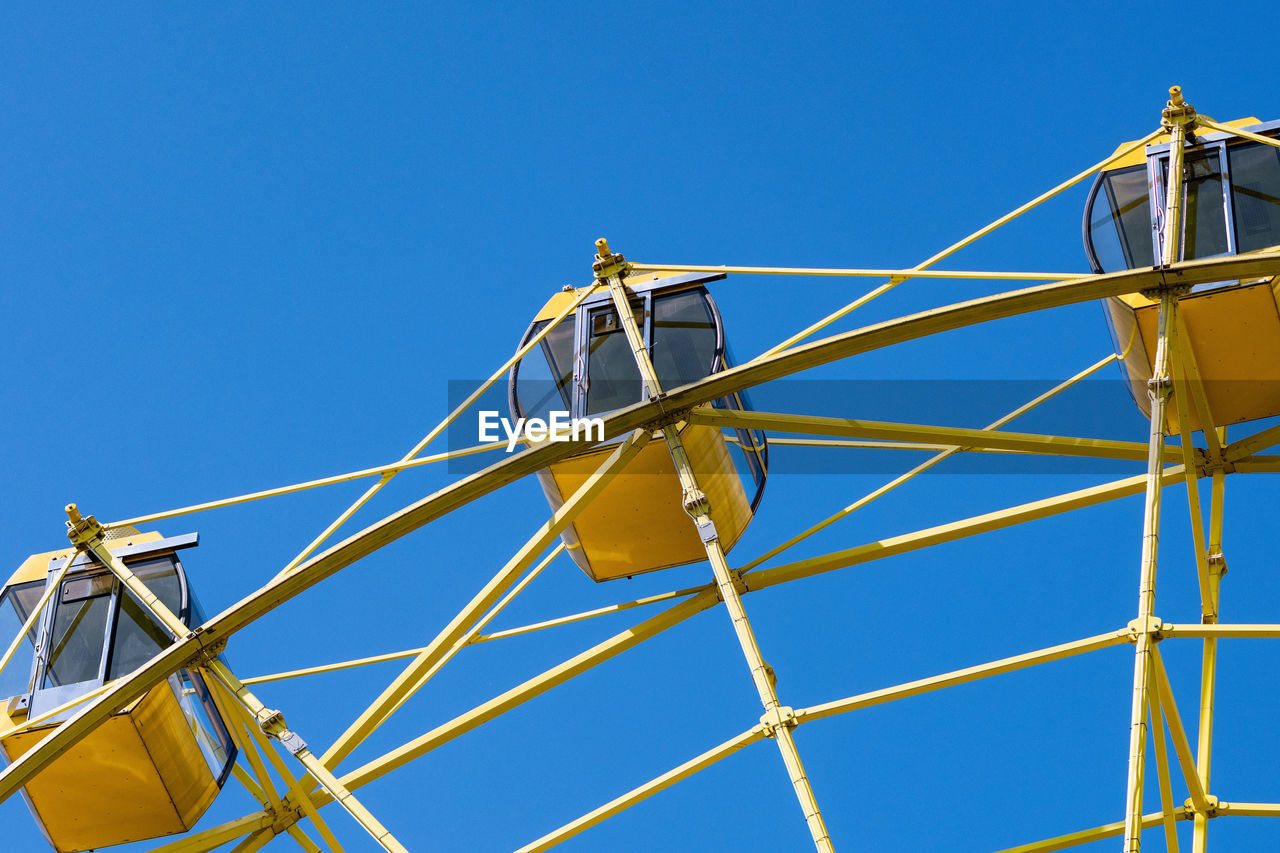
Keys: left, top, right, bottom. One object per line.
{"left": 0, "top": 87, "right": 1280, "bottom": 853}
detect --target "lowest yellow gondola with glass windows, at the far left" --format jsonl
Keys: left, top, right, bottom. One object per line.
{"left": 0, "top": 532, "right": 236, "bottom": 853}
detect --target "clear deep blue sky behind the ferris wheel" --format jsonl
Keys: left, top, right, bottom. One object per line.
{"left": 0, "top": 3, "right": 1280, "bottom": 852}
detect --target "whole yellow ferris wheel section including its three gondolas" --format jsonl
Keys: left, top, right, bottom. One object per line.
{"left": 0, "top": 87, "right": 1280, "bottom": 853}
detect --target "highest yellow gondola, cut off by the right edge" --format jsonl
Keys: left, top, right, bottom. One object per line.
{"left": 1084, "top": 118, "right": 1280, "bottom": 433}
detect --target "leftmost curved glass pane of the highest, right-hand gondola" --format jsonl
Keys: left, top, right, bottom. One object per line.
{"left": 1089, "top": 167, "right": 1155, "bottom": 273}
